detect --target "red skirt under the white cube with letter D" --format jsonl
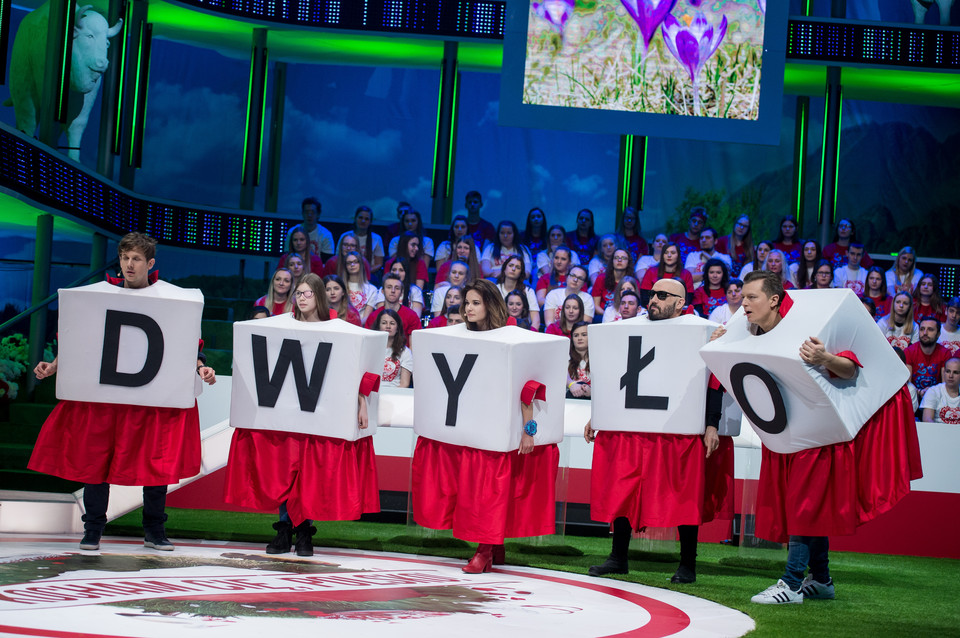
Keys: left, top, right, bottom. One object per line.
{"left": 27, "top": 401, "right": 200, "bottom": 485}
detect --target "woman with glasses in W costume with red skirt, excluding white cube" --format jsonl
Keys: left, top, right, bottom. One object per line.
{"left": 224, "top": 273, "right": 380, "bottom": 556}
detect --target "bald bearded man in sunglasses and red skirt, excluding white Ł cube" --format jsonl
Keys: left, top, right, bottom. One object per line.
{"left": 584, "top": 279, "right": 733, "bottom": 584}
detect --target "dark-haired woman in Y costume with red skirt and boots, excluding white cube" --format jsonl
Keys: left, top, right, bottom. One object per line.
{"left": 412, "top": 279, "right": 560, "bottom": 574}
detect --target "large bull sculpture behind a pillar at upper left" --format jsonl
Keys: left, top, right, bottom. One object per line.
{"left": 5, "top": 2, "right": 123, "bottom": 160}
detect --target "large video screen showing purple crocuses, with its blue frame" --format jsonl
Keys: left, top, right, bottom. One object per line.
{"left": 500, "top": 0, "right": 787, "bottom": 144}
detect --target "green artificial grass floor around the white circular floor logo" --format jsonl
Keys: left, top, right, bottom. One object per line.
{"left": 105, "top": 509, "right": 960, "bottom": 638}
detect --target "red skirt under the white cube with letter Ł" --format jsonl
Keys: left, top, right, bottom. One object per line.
{"left": 590, "top": 430, "right": 708, "bottom": 529}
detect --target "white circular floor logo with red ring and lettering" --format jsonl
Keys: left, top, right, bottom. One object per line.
{"left": 0, "top": 537, "right": 754, "bottom": 638}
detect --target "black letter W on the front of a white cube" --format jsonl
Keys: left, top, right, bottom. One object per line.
{"left": 252, "top": 335, "right": 333, "bottom": 412}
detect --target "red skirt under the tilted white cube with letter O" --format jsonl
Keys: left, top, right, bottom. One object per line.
{"left": 756, "top": 387, "right": 923, "bottom": 543}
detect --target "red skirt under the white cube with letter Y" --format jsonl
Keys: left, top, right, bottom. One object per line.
{"left": 413, "top": 436, "right": 560, "bottom": 544}
